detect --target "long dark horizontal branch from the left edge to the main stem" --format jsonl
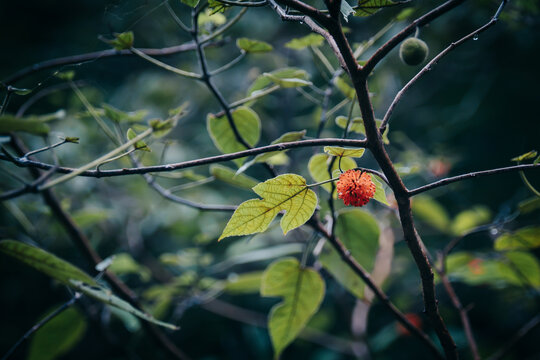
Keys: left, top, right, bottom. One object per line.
{"left": 0, "top": 138, "right": 367, "bottom": 178}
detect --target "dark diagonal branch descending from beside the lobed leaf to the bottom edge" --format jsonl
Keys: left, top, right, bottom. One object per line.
{"left": 309, "top": 218, "right": 443, "bottom": 359}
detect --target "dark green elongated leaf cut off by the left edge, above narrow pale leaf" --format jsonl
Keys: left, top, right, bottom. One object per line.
{"left": 0, "top": 240, "right": 96, "bottom": 286}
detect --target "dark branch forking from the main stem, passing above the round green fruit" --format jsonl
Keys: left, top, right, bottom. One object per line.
{"left": 362, "top": 0, "right": 465, "bottom": 76}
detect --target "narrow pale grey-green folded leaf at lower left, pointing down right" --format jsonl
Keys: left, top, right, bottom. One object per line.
{"left": 70, "top": 280, "right": 178, "bottom": 330}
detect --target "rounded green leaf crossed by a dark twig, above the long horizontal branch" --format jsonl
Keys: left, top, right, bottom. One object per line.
{"left": 207, "top": 106, "right": 261, "bottom": 166}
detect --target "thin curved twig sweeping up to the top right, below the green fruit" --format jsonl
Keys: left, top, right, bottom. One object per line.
{"left": 379, "top": 0, "right": 507, "bottom": 134}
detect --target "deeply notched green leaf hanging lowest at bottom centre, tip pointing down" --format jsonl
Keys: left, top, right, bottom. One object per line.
{"left": 261, "top": 258, "right": 325, "bottom": 359}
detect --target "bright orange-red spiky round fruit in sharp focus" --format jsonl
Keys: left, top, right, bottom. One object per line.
{"left": 336, "top": 170, "right": 375, "bottom": 206}
